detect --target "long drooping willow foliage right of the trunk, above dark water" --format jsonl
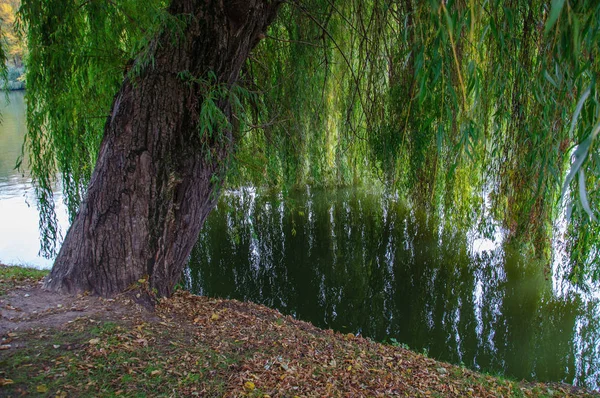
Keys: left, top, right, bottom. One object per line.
{"left": 239, "top": 0, "right": 600, "bottom": 280}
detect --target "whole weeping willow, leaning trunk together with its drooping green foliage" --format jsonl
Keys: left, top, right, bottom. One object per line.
{"left": 12, "top": 0, "right": 600, "bottom": 295}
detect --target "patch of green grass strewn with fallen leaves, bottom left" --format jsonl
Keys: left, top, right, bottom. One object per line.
{"left": 0, "top": 320, "right": 224, "bottom": 397}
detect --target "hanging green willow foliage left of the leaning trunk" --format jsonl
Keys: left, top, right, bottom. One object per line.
{"left": 20, "top": 0, "right": 165, "bottom": 256}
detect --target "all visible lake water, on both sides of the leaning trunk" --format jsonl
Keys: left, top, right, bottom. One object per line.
{"left": 0, "top": 93, "right": 600, "bottom": 389}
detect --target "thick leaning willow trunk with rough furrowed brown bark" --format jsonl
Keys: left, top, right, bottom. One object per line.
{"left": 45, "top": 0, "right": 280, "bottom": 296}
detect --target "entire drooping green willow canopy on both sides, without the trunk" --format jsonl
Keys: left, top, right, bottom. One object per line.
{"left": 8, "top": 0, "right": 600, "bottom": 286}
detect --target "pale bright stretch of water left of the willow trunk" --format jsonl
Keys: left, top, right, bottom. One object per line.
{"left": 0, "top": 92, "right": 68, "bottom": 268}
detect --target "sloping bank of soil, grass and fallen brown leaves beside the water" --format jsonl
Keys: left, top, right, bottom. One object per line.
{"left": 0, "top": 266, "right": 600, "bottom": 397}
